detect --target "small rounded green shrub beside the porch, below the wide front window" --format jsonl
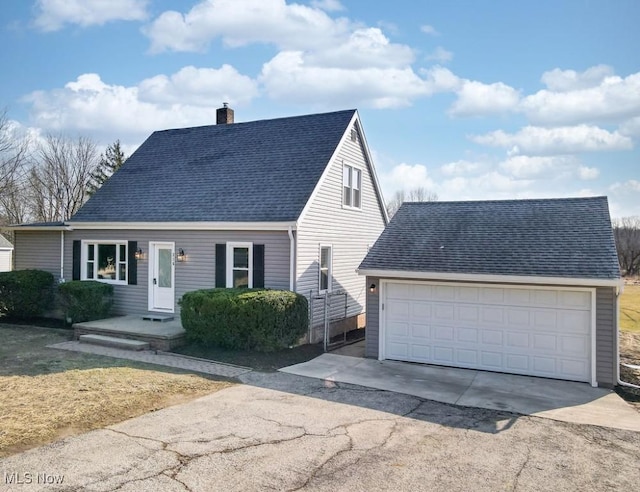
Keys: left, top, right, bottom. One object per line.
{"left": 58, "top": 280, "right": 113, "bottom": 323}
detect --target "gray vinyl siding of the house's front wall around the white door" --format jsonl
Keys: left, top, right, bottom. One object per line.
{"left": 58, "top": 230, "right": 289, "bottom": 314}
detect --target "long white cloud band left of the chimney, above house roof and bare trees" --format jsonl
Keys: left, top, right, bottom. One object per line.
{"left": 25, "top": 69, "right": 256, "bottom": 140}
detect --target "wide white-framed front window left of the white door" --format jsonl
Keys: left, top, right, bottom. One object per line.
{"left": 81, "top": 241, "right": 128, "bottom": 284}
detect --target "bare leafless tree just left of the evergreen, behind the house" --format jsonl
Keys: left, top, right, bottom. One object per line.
{"left": 28, "top": 135, "right": 99, "bottom": 222}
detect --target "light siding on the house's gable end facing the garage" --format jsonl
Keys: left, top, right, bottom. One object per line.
{"left": 296, "top": 123, "right": 385, "bottom": 326}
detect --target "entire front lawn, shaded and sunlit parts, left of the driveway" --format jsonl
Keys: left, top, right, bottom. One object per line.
{"left": 0, "top": 324, "right": 230, "bottom": 458}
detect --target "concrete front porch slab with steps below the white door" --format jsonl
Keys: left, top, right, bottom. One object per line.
{"left": 73, "top": 313, "right": 186, "bottom": 351}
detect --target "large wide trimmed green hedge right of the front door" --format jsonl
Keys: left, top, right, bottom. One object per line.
{"left": 180, "top": 288, "right": 309, "bottom": 352}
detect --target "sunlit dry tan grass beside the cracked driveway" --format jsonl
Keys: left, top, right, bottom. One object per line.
{"left": 0, "top": 367, "right": 229, "bottom": 456}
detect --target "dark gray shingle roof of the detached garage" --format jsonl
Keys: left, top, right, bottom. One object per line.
{"left": 360, "top": 197, "right": 620, "bottom": 279}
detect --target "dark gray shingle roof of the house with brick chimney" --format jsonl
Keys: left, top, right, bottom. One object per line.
{"left": 70, "top": 110, "right": 355, "bottom": 223}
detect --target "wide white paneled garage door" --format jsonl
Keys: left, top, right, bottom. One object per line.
{"left": 381, "top": 282, "right": 591, "bottom": 382}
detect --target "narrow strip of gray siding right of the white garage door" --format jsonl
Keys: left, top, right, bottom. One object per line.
{"left": 596, "top": 287, "right": 618, "bottom": 387}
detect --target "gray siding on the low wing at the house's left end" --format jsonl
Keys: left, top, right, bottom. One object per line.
{"left": 13, "top": 231, "right": 66, "bottom": 282}
